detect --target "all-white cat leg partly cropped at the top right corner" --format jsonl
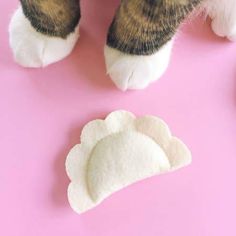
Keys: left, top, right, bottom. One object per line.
{"left": 204, "top": 0, "right": 236, "bottom": 41}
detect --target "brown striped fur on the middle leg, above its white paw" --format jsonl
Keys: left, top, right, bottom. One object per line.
{"left": 107, "top": 0, "right": 200, "bottom": 55}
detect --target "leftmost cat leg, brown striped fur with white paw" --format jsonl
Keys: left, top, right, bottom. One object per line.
{"left": 9, "top": 0, "right": 80, "bottom": 67}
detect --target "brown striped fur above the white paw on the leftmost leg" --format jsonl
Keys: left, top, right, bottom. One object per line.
{"left": 21, "top": 0, "right": 80, "bottom": 38}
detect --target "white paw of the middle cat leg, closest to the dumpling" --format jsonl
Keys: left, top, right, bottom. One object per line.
{"left": 104, "top": 40, "right": 173, "bottom": 91}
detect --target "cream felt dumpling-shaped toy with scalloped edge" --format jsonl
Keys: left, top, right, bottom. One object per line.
{"left": 66, "top": 111, "right": 191, "bottom": 213}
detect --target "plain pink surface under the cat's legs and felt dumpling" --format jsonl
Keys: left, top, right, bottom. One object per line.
{"left": 0, "top": 0, "right": 236, "bottom": 236}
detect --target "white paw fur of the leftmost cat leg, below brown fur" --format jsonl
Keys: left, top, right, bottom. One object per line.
{"left": 9, "top": 7, "right": 79, "bottom": 68}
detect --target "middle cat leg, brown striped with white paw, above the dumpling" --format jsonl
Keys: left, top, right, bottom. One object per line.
{"left": 105, "top": 0, "right": 201, "bottom": 90}
